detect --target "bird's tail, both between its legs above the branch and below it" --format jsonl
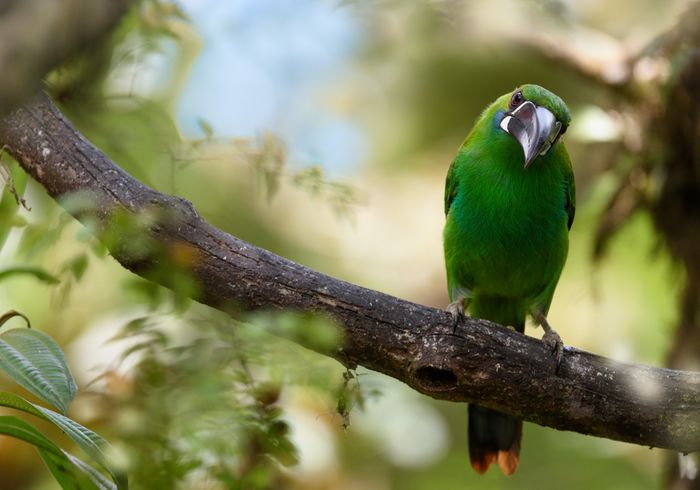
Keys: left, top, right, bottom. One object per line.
{"left": 468, "top": 297, "right": 525, "bottom": 475}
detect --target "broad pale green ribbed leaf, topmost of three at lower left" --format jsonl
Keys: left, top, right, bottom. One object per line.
{"left": 0, "top": 328, "right": 77, "bottom": 413}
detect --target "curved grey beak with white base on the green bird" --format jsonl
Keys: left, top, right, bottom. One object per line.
{"left": 501, "top": 101, "right": 561, "bottom": 168}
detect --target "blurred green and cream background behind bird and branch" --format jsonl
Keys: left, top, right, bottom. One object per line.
{"left": 0, "top": 0, "right": 700, "bottom": 490}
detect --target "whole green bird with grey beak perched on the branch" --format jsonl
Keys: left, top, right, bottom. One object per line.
{"left": 444, "top": 85, "right": 576, "bottom": 475}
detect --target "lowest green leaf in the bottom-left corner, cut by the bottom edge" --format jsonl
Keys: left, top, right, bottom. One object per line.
{"left": 0, "top": 415, "right": 117, "bottom": 490}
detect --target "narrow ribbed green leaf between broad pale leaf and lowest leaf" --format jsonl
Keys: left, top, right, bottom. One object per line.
{"left": 0, "top": 391, "right": 127, "bottom": 489}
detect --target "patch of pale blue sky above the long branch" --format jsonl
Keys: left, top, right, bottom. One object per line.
{"left": 176, "top": 0, "right": 367, "bottom": 175}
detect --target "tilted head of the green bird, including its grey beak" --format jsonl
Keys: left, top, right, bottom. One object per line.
{"left": 498, "top": 85, "right": 571, "bottom": 168}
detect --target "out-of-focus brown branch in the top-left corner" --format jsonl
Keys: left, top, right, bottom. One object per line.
{"left": 0, "top": 0, "right": 132, "bottom": 115}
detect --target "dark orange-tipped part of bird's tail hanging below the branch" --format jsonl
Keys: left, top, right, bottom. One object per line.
{"left": 468, "top": 404, "right": 523, "bottom": 475}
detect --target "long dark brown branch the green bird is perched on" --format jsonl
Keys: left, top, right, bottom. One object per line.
{"left": 0, "top": 95, "right": 700, "bottom": 452}
